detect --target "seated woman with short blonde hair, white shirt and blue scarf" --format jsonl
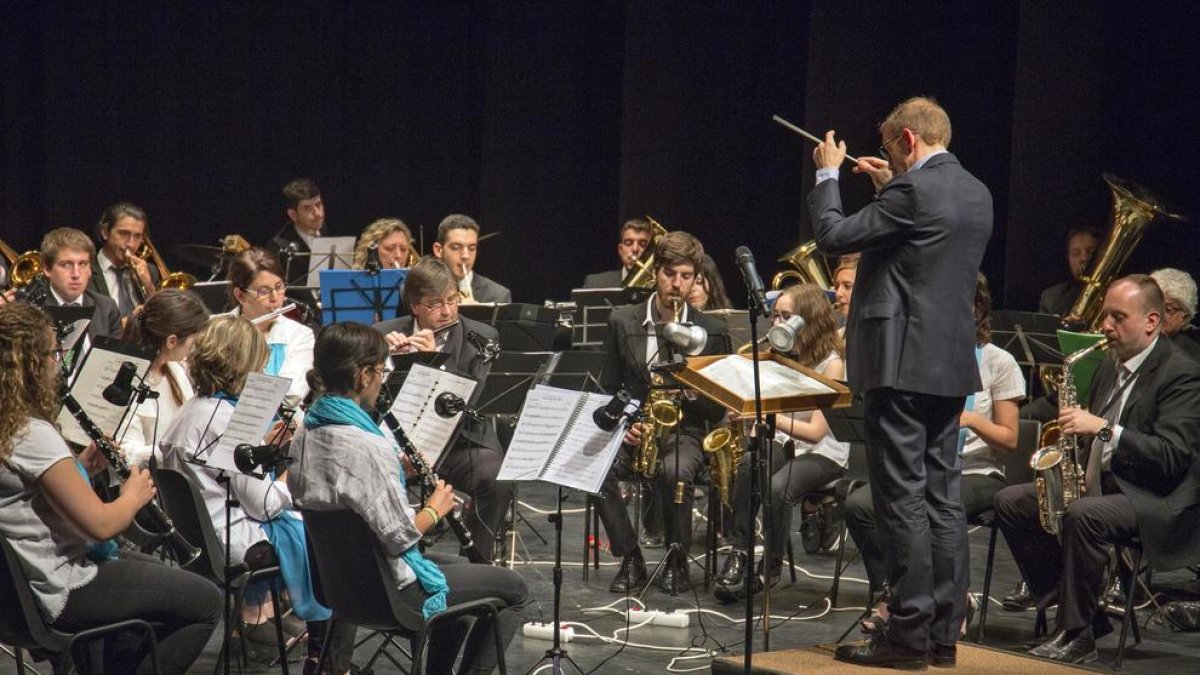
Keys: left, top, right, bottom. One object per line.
{"left": 158, "top": 316, "right": 354, "bottom": 673}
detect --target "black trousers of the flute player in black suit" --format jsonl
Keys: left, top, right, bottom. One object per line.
{"left": 437, "top": 446, "right": 512, "bottom": 560}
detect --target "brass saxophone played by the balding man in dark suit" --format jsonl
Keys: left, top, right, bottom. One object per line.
{"left": 1030, "top": 340, "right": 1110, "bottom": 537}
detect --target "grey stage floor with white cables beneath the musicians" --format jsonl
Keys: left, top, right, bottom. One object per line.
{"left": 0, "top": 484, "right": 1200, "bottom": 675}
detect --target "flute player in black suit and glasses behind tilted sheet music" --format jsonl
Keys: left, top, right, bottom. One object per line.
{"left": 376, "top": 256, "right": 512, "bottom": 558}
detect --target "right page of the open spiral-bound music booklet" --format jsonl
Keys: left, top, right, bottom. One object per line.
{"left": 537, "top": 393, "right": 625, "bottom": 494}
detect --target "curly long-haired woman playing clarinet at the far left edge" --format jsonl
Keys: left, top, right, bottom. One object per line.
{"left": 0, "top": 300, "right": 221, "bottom": 675}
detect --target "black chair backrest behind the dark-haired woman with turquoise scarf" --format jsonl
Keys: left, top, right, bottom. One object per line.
{"left": 300, "top": 509, "right": 424, "bottom": 632}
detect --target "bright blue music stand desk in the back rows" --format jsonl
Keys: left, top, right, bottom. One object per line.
{"left": 320, "top": 269, "right": 408, "bottom": 325}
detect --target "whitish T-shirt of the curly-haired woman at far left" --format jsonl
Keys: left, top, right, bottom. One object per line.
{"left": 0, "top": 419, "right": 96, "bottom": 622}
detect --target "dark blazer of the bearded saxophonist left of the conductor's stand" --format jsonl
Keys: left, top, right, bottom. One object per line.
{"left": 600, "top": 299, "right": 730, "bottom": 434}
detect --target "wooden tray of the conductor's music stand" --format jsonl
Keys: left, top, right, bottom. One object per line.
{"left": 674, "top": 352, "right": 851, "bottom": 418}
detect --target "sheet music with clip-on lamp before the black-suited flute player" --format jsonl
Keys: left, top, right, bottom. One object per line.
{"left": 391, "top": 363, "right": 479, "bottom": 466}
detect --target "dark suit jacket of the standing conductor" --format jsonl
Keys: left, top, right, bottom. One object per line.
{"left": 809, "top": 153, "right": 992, "bottom": 396}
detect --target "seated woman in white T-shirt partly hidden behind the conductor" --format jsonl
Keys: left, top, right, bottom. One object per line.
{"left": 846, "top": 273, "right": 1025, "bottom": 633}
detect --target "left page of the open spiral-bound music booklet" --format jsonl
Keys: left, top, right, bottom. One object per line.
{"left": 496, "top": 384, "right": 582, "bottom": 480}
